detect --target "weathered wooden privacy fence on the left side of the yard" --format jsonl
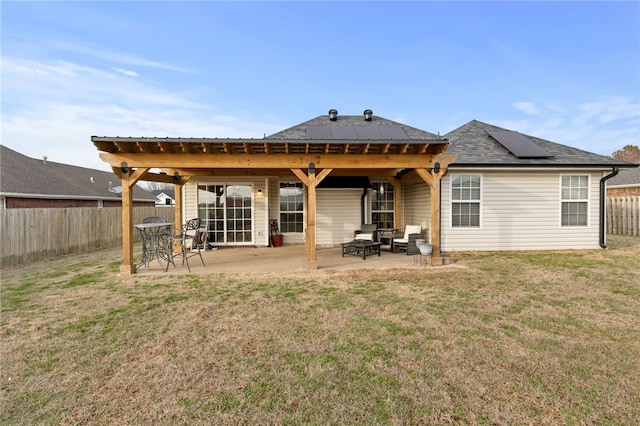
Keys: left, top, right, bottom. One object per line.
{"left": 0, "top": 207, "right": 174, "bottom": 266}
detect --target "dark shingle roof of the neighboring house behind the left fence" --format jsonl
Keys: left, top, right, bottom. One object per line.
{"left": 0, "top": 145, "right": 155, "bottom": 202}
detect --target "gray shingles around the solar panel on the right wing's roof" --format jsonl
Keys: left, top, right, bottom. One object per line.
{"left": 444, "top": 120, "right": 637, "bottom": 168}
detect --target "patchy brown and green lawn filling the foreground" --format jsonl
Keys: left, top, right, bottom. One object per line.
{"left": 0, "top": 237, "right": 640, "bottom": 425}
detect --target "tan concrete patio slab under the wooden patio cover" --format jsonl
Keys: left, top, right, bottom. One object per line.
{"left": 136, "top": 245, "right": 444, "bottom": 275}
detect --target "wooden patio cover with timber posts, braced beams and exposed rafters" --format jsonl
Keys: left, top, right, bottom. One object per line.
{"left": 91, "top": 136, "right": 455, "bottom": 274}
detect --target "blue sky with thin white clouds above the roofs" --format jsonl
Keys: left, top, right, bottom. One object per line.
{"left": 0, "top": 1, "right": 640, "bottom": 170}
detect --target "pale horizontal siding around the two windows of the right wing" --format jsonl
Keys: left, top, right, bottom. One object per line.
{"left": 441, "top": 170, "right": 602, "bottom": 251}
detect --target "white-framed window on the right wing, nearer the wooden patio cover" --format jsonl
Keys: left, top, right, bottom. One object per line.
{"left": 451, "top": 175, "right": 480, "bottom": 228}
